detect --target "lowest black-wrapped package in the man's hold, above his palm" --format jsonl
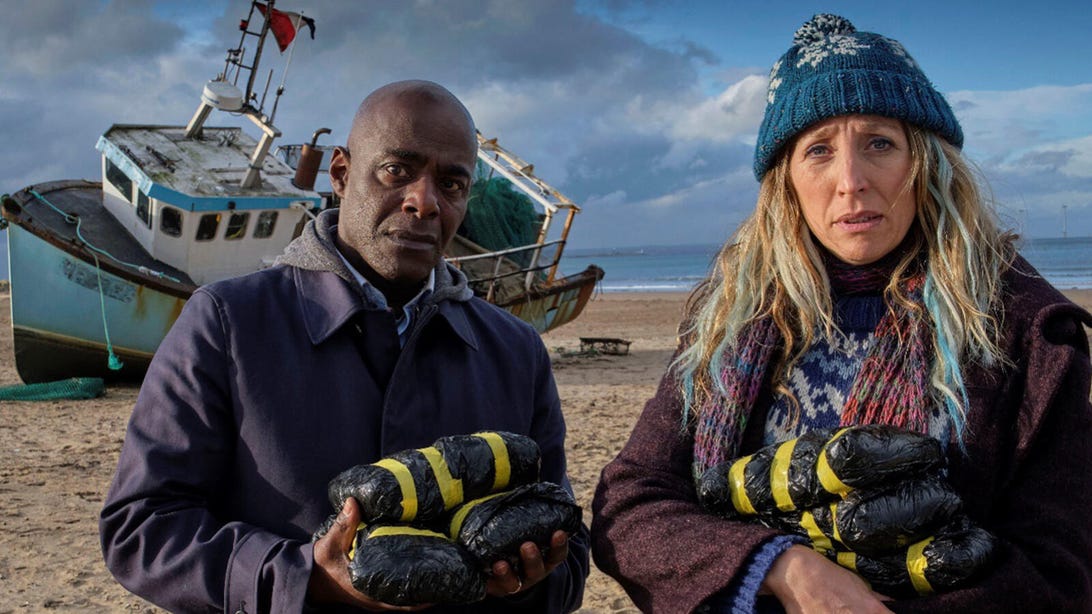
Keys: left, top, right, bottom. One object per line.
{"left": 348, "top": 524, "right": 485, "bottom": 605}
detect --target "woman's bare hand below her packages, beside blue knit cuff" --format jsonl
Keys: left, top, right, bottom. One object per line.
{"left": 760, "top": 545, "right": 891, "bottom": 614}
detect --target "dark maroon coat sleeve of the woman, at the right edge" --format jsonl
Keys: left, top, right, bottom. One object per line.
{"left": 892, "top": 305, "right": 1092, "bottom": 613}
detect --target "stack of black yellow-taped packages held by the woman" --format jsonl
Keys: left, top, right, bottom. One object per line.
{"left": 698, "top": 425, "right": 995, "bottom": 597}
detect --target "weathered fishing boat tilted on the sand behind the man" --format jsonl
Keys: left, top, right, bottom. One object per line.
{"left": 0, "top": 1, "right": 603, "bottom": 383}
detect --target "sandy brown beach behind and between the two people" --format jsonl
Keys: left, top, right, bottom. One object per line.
{"left": 0, "top": 291, "right": 1092, "bottom": 614}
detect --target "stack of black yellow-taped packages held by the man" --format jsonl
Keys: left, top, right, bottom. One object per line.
{"left": 316, "top": 432, "right": 581, "bottom": 605}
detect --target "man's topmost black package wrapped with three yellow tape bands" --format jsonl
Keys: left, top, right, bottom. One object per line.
{"left": 327, "top": 432, "right": 541, "bottom": 524}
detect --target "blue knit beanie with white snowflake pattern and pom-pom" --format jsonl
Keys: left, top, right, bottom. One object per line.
{"left": 755, "top": 14, "right": 963, "bottom": 181}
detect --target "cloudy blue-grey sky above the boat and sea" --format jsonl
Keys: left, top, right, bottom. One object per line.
{"left": 0, "top": 0, "right": 1092, "bottom": 248}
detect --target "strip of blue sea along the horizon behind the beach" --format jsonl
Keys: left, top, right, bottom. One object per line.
{"left": 0, "top": 232, "right": 1092, "bottom": 292}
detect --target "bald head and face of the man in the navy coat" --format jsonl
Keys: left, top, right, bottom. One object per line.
{"left": 330, "top": 92, "right": 477, "bottom": 286}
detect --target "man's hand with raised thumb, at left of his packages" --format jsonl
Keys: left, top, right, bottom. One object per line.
{"left": 307, "top": 497, "right": 431, "bottom": 612}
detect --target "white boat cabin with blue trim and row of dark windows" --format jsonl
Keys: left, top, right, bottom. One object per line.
{"left": 95, "top": 125, "right": 322, "bottom": 285}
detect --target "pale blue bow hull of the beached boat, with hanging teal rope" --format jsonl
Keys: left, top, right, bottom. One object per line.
{"left": 0, "top": 180, "right": 195, "bottom": 383}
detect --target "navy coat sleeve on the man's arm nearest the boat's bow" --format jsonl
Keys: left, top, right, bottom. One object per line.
{"left": 99, "top": 290, "right": 312, "bottom": 612}
